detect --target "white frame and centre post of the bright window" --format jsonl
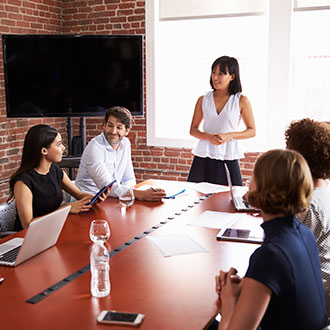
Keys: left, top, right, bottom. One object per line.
{"left": 146, "top": 0, "right": 330, "bottom": 152}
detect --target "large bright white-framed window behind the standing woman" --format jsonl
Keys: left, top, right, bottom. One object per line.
{"left": 146, "top": 0, "right": 330, "bottom": 151}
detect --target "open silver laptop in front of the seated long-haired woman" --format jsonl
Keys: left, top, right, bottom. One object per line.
{"left": 0, "top": 206, "right": 71, "bottom": 266}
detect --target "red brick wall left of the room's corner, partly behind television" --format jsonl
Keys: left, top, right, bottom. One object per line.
{"left": 0, "top": 0, "right": 67, "bottom": 203}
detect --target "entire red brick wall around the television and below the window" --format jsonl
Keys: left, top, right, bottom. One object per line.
{"left": 0, "top": 0, "right": 257, "bottom": 203}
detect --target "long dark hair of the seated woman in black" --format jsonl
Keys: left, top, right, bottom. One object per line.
{"left": 7, "top": 124, "right": 58, "bottom": 201}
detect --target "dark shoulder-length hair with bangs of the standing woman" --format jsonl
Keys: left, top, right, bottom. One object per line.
{"left": 210, "top": 56, "right": 242, "bottom": 95}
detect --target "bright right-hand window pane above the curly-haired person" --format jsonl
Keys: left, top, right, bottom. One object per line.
{"left": 289, "top": 9, "right": 330, "bottom": 121}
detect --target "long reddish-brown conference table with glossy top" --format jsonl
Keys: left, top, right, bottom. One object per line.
{"left": 0, "top": 180, "right": 259, "bottom": 330}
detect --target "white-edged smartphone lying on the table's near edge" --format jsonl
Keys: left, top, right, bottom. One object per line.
{"left": 97, "top": 311, "right": 144, "bottom": 327}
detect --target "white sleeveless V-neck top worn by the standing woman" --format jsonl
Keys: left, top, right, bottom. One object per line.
{"left": 192, "top": 91, "right": 244, "bottom": 160}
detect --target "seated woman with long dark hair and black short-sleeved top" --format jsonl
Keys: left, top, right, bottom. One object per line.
{"left": 8, "top": 125, "right": 105, "bottom": 231}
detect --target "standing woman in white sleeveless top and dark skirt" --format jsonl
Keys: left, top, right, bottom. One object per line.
{"left": 187, "top": 56, "right": 256, "bottom": 186}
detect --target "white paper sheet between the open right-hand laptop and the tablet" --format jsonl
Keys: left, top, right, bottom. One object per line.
{"left": 190, "top": 211, "right": 240, "bottom": 229}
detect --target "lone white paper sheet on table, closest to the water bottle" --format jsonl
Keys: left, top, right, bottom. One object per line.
{"left": 146, "top": 233, "right": 208, "bottom": 257}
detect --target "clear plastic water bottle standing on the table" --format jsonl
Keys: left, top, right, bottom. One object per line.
{"left": 90, "top": 242, "right": 110, "bottom": 298}
